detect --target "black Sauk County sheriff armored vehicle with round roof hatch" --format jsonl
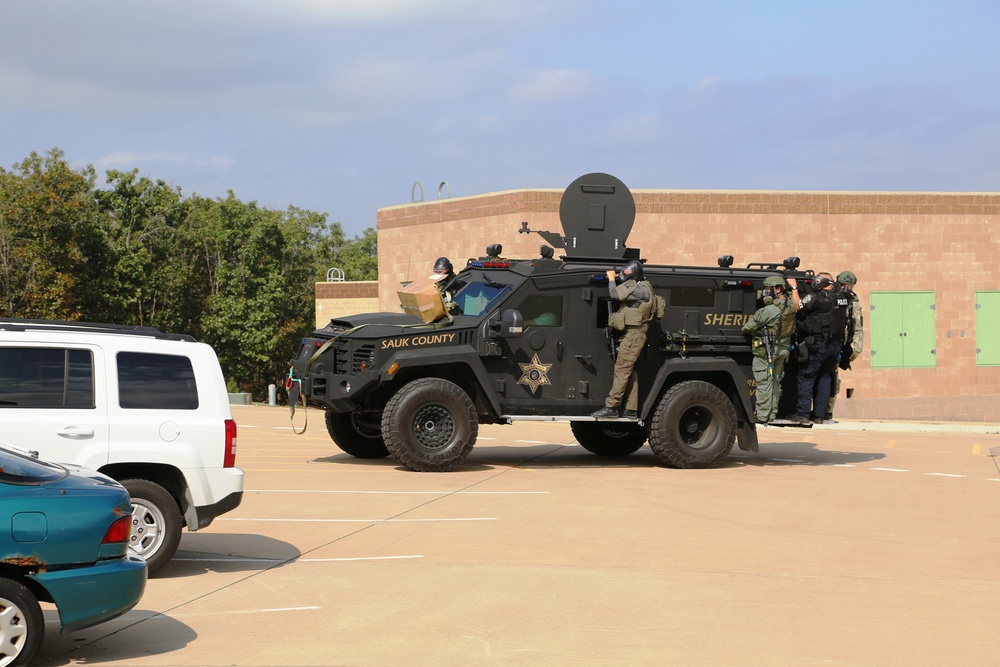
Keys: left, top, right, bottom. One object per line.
{"left": 287, "top": 173, "right": 811, "bottom": 471}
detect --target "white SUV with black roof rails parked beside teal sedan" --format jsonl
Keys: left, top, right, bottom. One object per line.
{"left": 0, "top": 319, "right": 243, "bottom": 573}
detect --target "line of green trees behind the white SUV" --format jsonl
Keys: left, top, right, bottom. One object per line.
{"left": 0, "top": 148, "right": 378, "bottom": 399}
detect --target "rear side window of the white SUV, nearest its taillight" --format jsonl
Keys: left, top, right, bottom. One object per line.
{"left": 118, "top": 352, "right": 198, "bottom": 410}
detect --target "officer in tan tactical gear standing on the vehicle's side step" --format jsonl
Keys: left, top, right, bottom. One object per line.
{"left": 590, "top": 259, "right": 653, "bottom": 419}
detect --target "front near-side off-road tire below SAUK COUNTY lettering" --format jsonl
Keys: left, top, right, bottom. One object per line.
{"left": 382, "top": 378, "right": 479, "bottom": 472}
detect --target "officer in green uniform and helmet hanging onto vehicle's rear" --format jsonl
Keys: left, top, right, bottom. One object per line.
{"left": 743, "top": 276, "right": 796, "bottom": 424}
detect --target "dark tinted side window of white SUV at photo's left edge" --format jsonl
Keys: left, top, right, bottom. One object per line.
{"left": 0, "top": 347, "right": 94, "bottom": 409}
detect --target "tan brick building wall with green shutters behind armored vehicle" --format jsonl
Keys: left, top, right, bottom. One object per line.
{"left": 377, "top": 189, "right": 1000, "bottom": 421}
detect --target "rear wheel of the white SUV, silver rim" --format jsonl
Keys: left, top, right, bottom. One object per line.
{"left": 121, "top": 479, "right": 183, "bottom": 574}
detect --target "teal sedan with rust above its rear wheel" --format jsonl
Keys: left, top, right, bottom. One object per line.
{"left": 0, "top": 447, "right": 146, "bottom": 666}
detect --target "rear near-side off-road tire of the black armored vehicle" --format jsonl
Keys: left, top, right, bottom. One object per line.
{"left": 649, "top": 380, "right": 736, "bottom": 468}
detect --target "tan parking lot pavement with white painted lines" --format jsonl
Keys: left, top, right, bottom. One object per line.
{"left": 41, "top": 406, "right": 1000, "bottom": 665}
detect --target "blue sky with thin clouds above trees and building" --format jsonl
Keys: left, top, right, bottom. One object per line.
{"left": 0, "top": 0, "right": 1000, "bottom": 235}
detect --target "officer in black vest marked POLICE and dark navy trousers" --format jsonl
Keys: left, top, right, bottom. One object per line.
{"left": 788, "top": 273, "right": 848, "bottom": 424}
